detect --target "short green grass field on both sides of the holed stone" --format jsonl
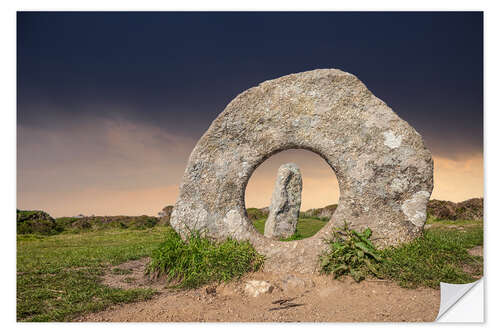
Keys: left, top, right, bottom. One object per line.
{"left": 17, "top": 219, "right": 483, "bottom": 321}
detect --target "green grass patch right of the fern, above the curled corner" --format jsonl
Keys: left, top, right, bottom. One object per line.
{"left": 380, "top": 222, "right": 483, "bottom": 288}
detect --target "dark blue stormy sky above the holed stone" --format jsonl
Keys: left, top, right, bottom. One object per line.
{"left": 17, "top": 12, "right": 483, "bottom": 215}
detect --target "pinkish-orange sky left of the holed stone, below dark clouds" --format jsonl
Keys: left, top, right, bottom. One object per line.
{"left": 17, "top": 118, "right": 195, "bottom": 215}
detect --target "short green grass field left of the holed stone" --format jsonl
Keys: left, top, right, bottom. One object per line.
{"left": 16, "top": 227, "right": 165, "bottom": 322}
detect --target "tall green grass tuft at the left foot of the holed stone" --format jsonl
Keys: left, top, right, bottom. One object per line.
{"left": 146, "top": 228, "right": 264, "bottom": 288}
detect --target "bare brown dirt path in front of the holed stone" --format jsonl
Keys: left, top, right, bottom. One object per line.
{"left": 77, "top": 260, "right": 440, "bottom": 322}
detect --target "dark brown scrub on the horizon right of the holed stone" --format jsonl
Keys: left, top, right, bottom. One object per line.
{"left": 427, "top": 198, "right": 483, "bottom": 221}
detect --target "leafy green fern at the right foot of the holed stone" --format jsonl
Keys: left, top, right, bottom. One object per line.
{"left": 320, "top": 222, "right": 383, "bottom": 282}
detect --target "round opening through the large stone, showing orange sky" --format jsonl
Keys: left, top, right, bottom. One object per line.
{"left": 244, "top": 149, "right": 340, "bottom": 241}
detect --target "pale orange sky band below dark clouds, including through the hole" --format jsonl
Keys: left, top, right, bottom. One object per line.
{"left": 17, "top": 117, "right": 483, "bottom": 216}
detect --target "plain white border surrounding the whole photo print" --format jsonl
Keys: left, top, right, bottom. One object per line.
{"left": 0, "top": 0, "right": 500, "bottom": 332}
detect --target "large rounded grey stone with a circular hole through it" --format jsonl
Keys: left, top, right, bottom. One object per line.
{"left": 170, "top": 69, "right": 433, "bottom": 272}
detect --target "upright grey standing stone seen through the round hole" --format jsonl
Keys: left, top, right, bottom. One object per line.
{"left": 264, "top": 163, "right": 302, "bottom": 239}
